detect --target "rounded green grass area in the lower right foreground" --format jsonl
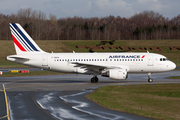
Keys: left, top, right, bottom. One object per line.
{"left": 87, "top": 84, "right": 180, "bottom": 120}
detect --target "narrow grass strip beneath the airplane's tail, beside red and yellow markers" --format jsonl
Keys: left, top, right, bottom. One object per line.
{"left": 0, "top": 71, "right": 62, "bottom": 77}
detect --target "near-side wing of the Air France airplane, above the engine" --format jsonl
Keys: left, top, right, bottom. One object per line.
{"left": 71, "top": 62, "right": 129, "bottom": 72}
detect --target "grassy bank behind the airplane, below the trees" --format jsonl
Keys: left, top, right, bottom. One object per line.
{"left": 0, "top": 40, "right": 180, "bottom": 68}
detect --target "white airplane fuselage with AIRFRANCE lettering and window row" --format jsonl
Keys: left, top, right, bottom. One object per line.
{"left": 7, "top": 53, "right": 176, "bottom": 74}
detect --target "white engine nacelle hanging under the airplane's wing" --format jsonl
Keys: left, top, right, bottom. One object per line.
{"left": 101, "top": 69, "right": 127, "bottom": 80}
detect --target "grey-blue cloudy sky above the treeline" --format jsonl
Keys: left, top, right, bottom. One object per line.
{"left": 0, "top": 0, "right": 180, "bottom": 18}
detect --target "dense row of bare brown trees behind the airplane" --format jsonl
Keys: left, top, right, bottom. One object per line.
{"left": 0, "top": 8, "right": 180, "bottom": 40}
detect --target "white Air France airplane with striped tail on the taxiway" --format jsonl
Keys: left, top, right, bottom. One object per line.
{"left": 6, "top": 23, "right": 176, "bottom": 83}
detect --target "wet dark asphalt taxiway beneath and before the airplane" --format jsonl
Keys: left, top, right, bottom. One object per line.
{"left": 0, "top": 71, "right": 180, "bottom": 120}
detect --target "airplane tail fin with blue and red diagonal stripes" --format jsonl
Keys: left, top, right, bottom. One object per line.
{"left": 9, "top": 23, "right": 44, "bottom": 54}
